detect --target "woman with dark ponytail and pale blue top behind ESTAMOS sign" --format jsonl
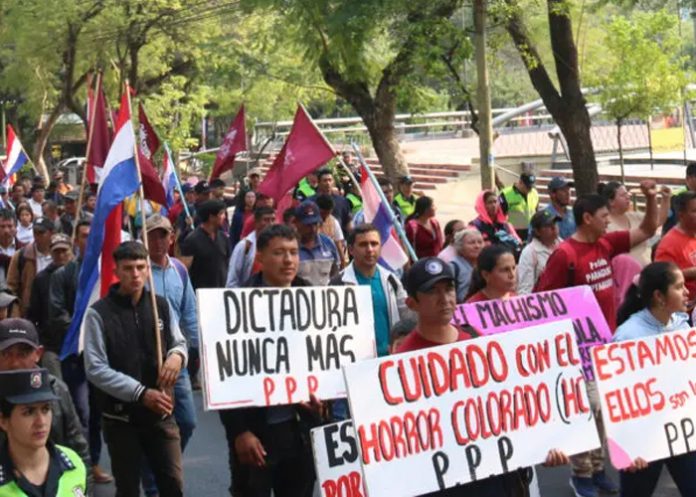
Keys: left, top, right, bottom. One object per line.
{"left": 614, "top": 262, "right": 696, "bottom": 497}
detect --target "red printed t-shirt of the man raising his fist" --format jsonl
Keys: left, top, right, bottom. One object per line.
{"left": 534, "top": 231, "right": 631, "bottom": 332}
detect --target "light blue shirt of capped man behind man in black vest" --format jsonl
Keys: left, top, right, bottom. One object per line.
{"left": 152, "top": 257, "right": 198, "bottom": 349}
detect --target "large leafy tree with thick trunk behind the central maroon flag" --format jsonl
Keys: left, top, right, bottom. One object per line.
{"left": 242, "top": 0, "right": 462, "bottom": 178}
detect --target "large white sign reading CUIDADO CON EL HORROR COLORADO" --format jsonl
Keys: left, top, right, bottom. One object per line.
{"left": 344, "top": 320, "right": 599, "bottom": 497}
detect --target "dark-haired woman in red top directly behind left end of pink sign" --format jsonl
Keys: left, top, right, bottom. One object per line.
{"left": 466, "top": 245, "right": 517, "bottom": 303}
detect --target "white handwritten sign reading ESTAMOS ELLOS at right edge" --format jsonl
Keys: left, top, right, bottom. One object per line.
{"left": 592, "top": 329, "right": 696, "bottom": 469}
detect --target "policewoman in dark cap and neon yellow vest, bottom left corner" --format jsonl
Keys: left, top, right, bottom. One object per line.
{"left": 0, "top": 369, "right": 87, "bottom": 497}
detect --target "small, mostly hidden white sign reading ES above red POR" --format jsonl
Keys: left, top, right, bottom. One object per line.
{"left": 310, "top": 419, "right": 365, "bottom": 497}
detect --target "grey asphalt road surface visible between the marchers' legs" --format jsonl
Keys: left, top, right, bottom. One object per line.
{"left": 96, "top": 392, "right": 678, "bottom": 497}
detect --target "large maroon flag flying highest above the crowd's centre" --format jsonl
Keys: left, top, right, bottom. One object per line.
{"left": 258, "top": 105, "right": 336, "bottom": 203}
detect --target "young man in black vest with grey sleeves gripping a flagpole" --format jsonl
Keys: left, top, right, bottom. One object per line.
{"left": 84, "top": 242, "right": 187, "bottom": 497}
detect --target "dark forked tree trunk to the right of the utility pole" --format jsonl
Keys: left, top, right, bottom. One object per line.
{"left": 495, "top": 0, "right": 597, "bottom": 194}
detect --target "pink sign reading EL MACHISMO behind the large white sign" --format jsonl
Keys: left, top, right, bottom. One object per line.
{"left": 453, "top": 285, "right": 611, "bottom": 380}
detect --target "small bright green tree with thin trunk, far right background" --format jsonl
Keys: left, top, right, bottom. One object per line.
{"left": 592, "top": 11, "right": 687, "bottom": 181}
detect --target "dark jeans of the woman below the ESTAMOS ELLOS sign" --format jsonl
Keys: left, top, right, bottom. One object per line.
{"left": 621, "top": 452, "right": 696, "bottom": 497}
